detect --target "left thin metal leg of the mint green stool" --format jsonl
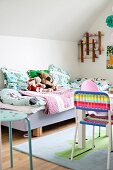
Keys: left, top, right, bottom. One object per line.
{"left": 9, "top": 122, "right": 13, "bottom": 168}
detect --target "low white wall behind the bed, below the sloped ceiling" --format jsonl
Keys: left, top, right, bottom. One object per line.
{"left": 0, "top": 36, "right": 78, "bottom": 76}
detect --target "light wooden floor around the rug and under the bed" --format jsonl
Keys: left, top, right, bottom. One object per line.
{"left": 2, "top": 120, "right": 74, "bottom": 170}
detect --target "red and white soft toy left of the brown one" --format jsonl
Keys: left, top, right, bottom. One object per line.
{"left": 28, "top": 77, "right": 45, "bottom": 92}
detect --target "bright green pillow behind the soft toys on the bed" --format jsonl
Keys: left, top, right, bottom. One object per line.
{"left": 27, "top": 70, "right": 49, "bottom": 78}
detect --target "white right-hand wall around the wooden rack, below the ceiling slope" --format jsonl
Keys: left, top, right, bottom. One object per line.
{"left": 79, "top": 2, "right": 113, "bottom": 82}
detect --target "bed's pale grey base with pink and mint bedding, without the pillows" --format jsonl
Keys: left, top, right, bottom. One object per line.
{"left": 0, "top": 89, "right": 75, "bottom": 136}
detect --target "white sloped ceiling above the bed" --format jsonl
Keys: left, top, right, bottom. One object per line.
{"left": 0, "top": 0, "right": 111, "bottom": 41}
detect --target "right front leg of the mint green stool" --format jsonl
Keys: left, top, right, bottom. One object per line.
{"left": 26, "top": 118, "right": 33, "bottom": 170}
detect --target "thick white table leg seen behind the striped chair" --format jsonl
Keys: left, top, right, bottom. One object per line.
{"left": 77, "top": 110, "right": 86, "bottom": 149}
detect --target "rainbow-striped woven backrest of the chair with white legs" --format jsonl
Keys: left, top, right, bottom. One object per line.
{"left": 74, "top": 91, "right": 110, "bottom": 112}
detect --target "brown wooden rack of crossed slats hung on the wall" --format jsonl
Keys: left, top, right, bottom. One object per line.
{"left": 78, "top": 31, "right": 104, "bottom": 62}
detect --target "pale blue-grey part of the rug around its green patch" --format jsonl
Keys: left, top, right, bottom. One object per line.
{"left": 13, "top": 128, "right": 113, "bottom": 170}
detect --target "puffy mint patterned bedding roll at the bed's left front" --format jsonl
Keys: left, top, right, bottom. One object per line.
{"left": 0, "top": 88, "right": 46, "bottom": 106}
